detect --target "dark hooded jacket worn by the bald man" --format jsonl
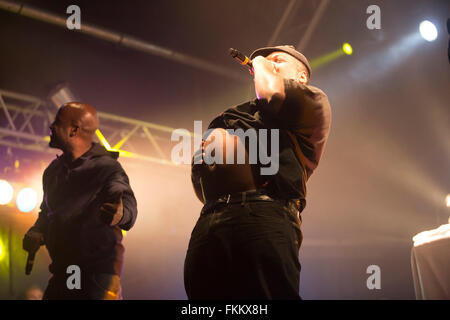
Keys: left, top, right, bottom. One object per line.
{"left": 32, "top": 143, "right": 137, "bottom": 275}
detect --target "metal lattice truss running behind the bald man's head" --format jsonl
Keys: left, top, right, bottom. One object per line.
{"left": 0, "top": 89, "right": 194, "bottom": 166}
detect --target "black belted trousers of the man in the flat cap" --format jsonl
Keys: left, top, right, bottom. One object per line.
{"left": 184, "top": 201, "right": 302, "bottom": 300}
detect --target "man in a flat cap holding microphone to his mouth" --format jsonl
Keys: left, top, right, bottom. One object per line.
{"left": 185, "top": 46, "right": 331, "bottom": 299}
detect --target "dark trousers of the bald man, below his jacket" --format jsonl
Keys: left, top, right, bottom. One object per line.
{"left": 43, "top": 273, "right": 122, "bottom": 300}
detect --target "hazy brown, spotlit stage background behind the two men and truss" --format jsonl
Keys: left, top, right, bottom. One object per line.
{"left": 0, "top": 0, "right": 450, "bottom": 299}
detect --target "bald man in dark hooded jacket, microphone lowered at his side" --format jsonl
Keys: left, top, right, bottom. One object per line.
{"left": 23, "top": 102, "right": 137, "bottom": 300}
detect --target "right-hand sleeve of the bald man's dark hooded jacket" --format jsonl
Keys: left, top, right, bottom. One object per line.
{"left": 106, "top": 162, "right": 137, "bottom": 230}
